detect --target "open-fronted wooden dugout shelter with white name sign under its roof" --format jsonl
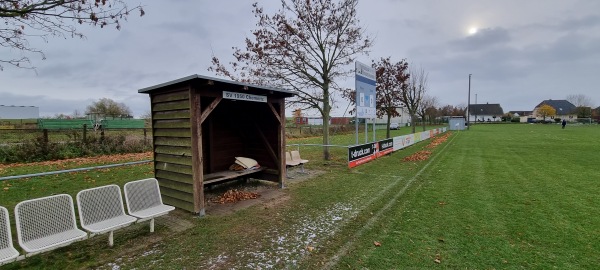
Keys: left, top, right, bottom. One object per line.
{"left": 138, "top": 75, "right": 295, "bottom": 215}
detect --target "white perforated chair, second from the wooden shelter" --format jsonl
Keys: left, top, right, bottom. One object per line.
{"left": 77, "top": 185, "right": 137, "bottom": 247}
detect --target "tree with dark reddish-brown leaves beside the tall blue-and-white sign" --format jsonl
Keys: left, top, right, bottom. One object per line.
{"left": 342, "top": 57, "right": 409, "bottom": 138}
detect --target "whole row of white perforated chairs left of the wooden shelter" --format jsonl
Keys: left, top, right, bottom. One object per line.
{"left": 0, "top": 178, "right": 175, "bottom": 265}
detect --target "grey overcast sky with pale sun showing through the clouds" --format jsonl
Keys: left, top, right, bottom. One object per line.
{"left": 0, "top": 0, "right": 600, "bottom": 117}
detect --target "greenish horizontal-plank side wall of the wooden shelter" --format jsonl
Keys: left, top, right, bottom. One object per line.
{"left": 151, "top": 88, "right": 194, "bottom": 212}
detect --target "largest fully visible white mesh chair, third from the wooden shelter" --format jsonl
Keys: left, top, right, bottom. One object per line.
{"left": 15, "top": 194, "right": 87, "bottom": 255}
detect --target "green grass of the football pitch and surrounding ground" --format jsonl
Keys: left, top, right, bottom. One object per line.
{"left": 0, "top": 124, "right": 600, "bottom": 269}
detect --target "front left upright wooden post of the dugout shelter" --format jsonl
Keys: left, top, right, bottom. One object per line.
{"left": 190, "top": 87, "right": 206, "bottom": 216}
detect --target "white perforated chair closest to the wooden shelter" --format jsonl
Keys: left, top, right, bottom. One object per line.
{"left": 124, "top": 178, "right": 175, "bottom": 232}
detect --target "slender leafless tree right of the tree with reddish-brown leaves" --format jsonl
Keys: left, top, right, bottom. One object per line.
{"left": 401, "top": 66, "right": 428, "bottom": 133}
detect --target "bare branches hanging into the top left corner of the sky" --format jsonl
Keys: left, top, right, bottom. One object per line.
{"left": 0, "top": 0, "right": 144, "bottom": 70}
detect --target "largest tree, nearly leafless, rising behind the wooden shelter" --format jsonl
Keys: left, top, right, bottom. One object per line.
{"left": 209, "top": 0, "right": 372, "bottom": 160}
